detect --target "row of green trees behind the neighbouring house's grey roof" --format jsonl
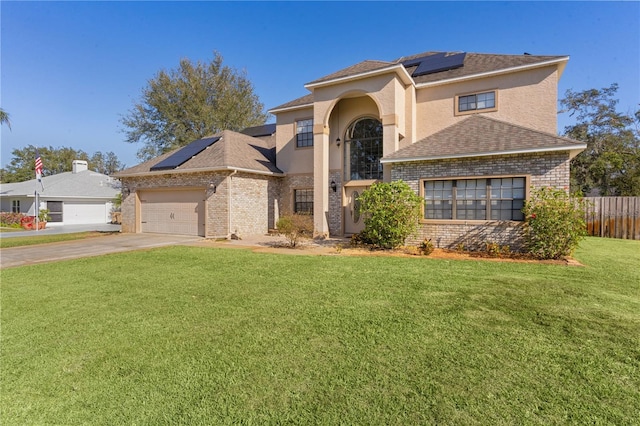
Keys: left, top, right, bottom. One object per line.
{"left": 0, "top": 145, "right": 124, "bottom": 183}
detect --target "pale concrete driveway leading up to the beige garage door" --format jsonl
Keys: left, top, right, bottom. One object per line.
{"left": 0, "top": 231, "right": 203, "bottom": 269}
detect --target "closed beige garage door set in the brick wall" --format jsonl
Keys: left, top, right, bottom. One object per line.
{"left": 140, "top": 190, "right": 204, "bottom": 236}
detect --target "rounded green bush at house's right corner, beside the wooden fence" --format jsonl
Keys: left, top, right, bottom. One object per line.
{"left": 522, "top": 187, "right": 587, "bottom": 259}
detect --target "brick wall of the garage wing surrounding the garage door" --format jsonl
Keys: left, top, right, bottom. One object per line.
{"left": 121, "top": 172, "right": 282, "bottom": 238}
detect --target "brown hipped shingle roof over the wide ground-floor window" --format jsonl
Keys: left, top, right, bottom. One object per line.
{"left": 381, "top": 115, "right": 586, "bottom": 163}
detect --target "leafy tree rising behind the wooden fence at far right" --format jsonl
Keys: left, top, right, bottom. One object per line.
{"left": 560, "top": 83, "right": 640, "bottom": 196}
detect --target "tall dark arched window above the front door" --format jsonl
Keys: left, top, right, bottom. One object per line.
{"left": 344, "top": 117, "right": 382, "bottom": 180}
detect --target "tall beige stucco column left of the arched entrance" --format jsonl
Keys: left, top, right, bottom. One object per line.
{"left": 313, "top": 124, "right": 329, "bottom": 237}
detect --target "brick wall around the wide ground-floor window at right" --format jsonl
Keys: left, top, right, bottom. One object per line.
{"left": 391, "top": 151, "right": 569, "bottom": 250}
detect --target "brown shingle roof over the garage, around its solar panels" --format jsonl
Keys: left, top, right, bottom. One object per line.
{"left": 114, "top": 130, "right": 282, "bottom": 177}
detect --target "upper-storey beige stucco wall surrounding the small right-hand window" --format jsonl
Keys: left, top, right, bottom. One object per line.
{"left": 416, "top": 66, "right": 558, "bottom": 137}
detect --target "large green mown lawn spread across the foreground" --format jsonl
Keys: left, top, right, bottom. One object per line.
{"left": 0, "top": 238, "right": 640, "bottom": 425}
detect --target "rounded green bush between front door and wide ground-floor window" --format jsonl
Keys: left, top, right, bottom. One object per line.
{"left": 359, "top": 180, "right": 422, "bottom": 249}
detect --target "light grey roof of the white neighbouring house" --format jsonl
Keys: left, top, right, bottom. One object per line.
{"left": 0, "top": 170, "right": 120, "bottom": 199}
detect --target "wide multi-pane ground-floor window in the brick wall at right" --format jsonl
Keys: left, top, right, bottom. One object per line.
{"left": 424, "top": 177, "right": 526, "bottom": 221}
